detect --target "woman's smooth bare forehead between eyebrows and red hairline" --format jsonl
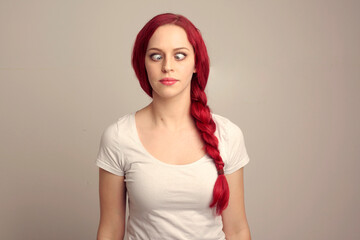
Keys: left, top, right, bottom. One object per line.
{"left": 148, "top": 24, "right": 192, "bottom": 49}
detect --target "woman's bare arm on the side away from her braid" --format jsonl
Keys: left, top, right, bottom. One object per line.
{"left": 98, "top": 168, "right": 126, "bottom": 240}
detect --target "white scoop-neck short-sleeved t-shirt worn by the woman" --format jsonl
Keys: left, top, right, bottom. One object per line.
{"left": 96, "top": 113, "right": 249, "bottom": 240}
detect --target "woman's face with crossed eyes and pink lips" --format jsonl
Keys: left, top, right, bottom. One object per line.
{"left": 145, "top": 24, "right": 196, "bottom": 98}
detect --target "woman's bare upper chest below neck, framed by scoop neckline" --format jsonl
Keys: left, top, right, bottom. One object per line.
{"left": 135, "top": 110, "right": 206, "bottom": 165}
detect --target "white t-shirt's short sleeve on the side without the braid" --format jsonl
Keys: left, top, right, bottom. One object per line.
{"left": 96, "top": 123, "right": 125, "bottom": 176}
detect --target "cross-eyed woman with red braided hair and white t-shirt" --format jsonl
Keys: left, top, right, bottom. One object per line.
{"left": 96, "top": 13, "right": 250, "bottom": 240}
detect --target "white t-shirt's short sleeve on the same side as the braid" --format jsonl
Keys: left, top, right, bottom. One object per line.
{"left": 224, "top": 121, "right": 250, "bottom": 174}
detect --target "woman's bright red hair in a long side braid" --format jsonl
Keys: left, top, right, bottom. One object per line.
{"left": 131, "top": 13, "right": 229, "bottom": 215}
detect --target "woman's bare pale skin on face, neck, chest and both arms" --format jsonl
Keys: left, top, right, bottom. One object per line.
{"left": 97, "top": 25, "right": 251, "bottom": 240}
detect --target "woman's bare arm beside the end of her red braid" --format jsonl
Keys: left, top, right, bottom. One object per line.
{"left": 222, "top": 167, "right": 249, "bottom": 236}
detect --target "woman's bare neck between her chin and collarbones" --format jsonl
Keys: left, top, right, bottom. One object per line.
{"left": 148, "top": 90, "right": 194, "bottom": 131}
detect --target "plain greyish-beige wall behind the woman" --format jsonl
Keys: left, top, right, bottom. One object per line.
{"left": 0, "top": 0, "right": 360, "bottom": 240}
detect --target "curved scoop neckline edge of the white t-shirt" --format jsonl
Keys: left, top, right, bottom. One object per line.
{"left": 129, "top": 112, "right": 209, "bottom": 168}
